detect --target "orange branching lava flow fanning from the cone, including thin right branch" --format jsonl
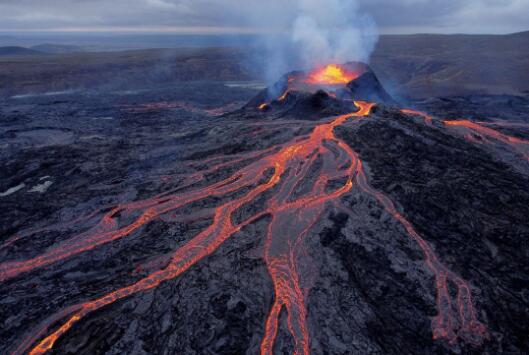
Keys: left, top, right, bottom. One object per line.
{"left": 9, "top": 102, "right": 485, "bottom": 355}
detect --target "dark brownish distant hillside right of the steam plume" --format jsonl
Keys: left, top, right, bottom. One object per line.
{"left": 370, "top": 32, "right": 529, "bottom": 98}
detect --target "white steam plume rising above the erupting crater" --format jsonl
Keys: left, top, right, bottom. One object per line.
{"left": 250, "top": 0, "right": 378, "bottom": 84}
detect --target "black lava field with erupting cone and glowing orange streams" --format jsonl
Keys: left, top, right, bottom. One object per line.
{"left": 0, "top": 68, "right": 529, "bottom": 354}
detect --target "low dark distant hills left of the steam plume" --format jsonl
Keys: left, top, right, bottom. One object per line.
{"left": 0, "top": 48, "right": 253, "bottom": 96}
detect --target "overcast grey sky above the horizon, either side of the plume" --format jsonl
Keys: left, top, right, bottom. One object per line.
{"left": 0, "top": 0, "right": 529, "bottom": 33}
